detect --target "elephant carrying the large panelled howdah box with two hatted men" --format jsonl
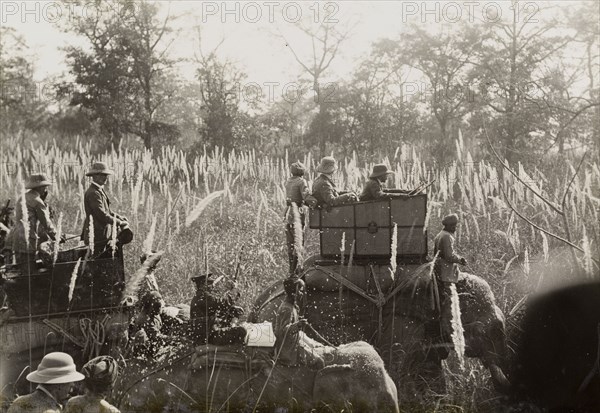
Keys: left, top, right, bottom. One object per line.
{"left": 249, "top": 257, "right": 509, "bottom": 397}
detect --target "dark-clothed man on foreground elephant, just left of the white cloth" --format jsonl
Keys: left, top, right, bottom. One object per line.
{"left": 190, "top": 274, "right": 246, "bottom": 345}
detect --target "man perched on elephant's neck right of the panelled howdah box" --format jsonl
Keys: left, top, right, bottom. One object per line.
{"left": 433, "top": 214, "right": 467, "bottom": 335}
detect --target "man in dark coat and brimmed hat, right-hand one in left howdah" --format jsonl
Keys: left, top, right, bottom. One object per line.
{"left": 81, "top": 162, "right": 133, "bottom": 249}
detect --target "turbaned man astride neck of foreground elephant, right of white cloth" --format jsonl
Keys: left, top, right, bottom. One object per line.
{"left": 274, "top": 277, "right": 325, "bottom": 369}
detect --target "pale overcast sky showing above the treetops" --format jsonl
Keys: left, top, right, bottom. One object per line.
{"left": 0, "top": 0, "right": 592, "bottom": 89}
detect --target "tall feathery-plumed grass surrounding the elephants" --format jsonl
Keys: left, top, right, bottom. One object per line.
{"left": 0, "top": 137, "right": 600, "bottom": 412}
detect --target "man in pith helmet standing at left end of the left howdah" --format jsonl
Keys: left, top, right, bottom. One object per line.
{"left": 5, "top": 173, "right": 56, "bottom": 274}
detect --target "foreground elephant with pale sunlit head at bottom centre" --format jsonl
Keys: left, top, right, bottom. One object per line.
{"left": 113, "top": 342, "right": 399, "bottom": 413}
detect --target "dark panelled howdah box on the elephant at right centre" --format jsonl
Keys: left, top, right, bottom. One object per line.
{"left": 309, "top": 194, "right": 427, "bottom": 260}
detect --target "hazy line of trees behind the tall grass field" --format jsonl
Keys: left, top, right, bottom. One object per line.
{"left": 0, "top": 0, "right": 600, "bottom": 161}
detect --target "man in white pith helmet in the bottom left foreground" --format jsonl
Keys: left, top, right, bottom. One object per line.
{"left": 7, "top": 352, "right": 85, "bottom": 413}
